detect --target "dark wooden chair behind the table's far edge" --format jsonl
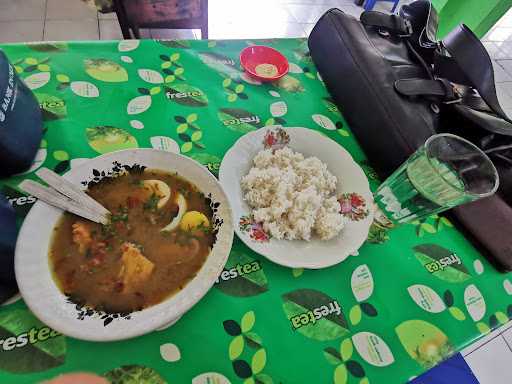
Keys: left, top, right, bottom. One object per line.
{"left": 114, "top": 0, "right": 208, "bottom": 39}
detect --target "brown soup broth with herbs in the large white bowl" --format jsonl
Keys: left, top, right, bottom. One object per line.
{"left": 49, "top": 170, "right": 214, "bottom": 313}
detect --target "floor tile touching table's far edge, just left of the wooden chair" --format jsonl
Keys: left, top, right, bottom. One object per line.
{"left": 44, "top": 20, "right": 99, "bottom": 41}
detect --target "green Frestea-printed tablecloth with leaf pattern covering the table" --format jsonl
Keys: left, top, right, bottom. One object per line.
{"left": 0, "top": 39, "right": 512, "bottom": 384}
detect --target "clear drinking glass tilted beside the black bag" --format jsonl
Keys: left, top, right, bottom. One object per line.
{"left": 374, "top": 133, "right": 499, "bottom": 224}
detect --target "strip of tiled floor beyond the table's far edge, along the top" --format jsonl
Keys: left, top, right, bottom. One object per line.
{"left": 0, "top": 0, "right": 391, "bottom": 43}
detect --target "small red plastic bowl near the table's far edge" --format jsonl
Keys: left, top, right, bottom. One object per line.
{"left": 240, "top": 45, "right": 288, "bottom": 81}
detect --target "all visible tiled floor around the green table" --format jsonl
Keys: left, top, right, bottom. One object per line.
{"left": 0, "top": 0, "right": 512, "bottom": 384}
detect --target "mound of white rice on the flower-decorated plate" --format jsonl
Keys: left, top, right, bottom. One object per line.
{"left": 241, "top": 147, "right": 345, "bottom": 241}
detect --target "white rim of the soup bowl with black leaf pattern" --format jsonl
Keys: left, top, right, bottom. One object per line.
{"left": 15, "top": 149, "right": 233, "bottom": 341}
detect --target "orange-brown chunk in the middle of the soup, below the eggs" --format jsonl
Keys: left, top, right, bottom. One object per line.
{"left": 119, "top": 243, "right": 155, "bottom": 293}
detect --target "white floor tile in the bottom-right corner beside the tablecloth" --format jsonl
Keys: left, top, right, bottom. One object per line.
{"left": 465, "top": 336, "right": 512, "bottom": 384}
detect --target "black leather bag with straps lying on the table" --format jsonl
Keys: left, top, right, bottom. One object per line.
{"left": 308, "top": 0, "right": 512, "bottom": 270}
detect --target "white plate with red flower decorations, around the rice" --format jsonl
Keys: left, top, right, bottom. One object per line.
{"left": 219, "top": 127, "right": 373, "bottom": 269}
